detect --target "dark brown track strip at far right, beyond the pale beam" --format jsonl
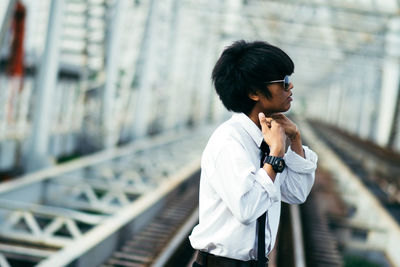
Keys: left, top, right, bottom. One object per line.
{"left": 312, "top": 121, "right": 400, "bottom": 223}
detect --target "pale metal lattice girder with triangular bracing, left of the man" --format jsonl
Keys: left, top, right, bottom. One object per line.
{"left": 0, "top": 129, "right": 209, "bottom": 266}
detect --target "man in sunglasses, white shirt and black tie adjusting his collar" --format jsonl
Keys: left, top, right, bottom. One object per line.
{"left": 189, "top": 41, "right": 317, "bottom": 266}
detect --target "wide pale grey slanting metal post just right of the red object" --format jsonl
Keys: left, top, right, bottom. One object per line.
{"left": 24, "top": 0, "right": 64, "bottom": 171}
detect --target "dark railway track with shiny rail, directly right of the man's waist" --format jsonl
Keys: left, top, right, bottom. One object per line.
{"left": 272, "top": 121, "right": 344, "bottom": 267}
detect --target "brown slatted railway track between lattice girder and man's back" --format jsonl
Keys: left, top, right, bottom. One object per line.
{"left": 102, "top": 173, "right": 199, "bottom": 267}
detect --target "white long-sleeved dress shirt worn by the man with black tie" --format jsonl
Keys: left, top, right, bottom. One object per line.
{"left": 189, "top": 113, "right": 318, "bottom": 261}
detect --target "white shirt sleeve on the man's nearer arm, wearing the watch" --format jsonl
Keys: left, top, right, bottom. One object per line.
{"left": 209, "top": 142, "right": 279, "bottom": 224}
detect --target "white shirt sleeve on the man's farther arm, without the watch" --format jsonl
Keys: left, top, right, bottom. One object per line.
{"left": 280, "top": 146, "right": 318, "bottom": 204}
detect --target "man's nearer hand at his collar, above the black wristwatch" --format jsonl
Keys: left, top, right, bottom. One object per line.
{"left": 258, "top": 112, "right": 286, "bottom": 157}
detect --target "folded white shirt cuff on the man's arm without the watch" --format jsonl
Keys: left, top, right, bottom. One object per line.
{"left": 284, "top": 146, "right": 318, "bottom": 174}
